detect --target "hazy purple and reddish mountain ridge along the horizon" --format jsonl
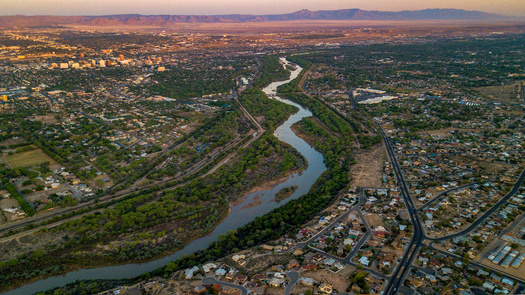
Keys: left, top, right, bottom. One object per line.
{"left": 0, "top": 8, "right": 511, "bottom": 27}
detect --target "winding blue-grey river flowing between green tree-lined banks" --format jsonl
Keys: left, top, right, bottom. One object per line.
{"left": 3, "top": 58, "right": 326, "bottom": 295}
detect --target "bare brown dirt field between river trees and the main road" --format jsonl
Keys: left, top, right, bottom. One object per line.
{"left": 350, "top": 144, "right": 388, "bottom": 187}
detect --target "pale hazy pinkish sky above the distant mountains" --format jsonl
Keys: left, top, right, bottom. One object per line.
{"left": 4, "top": 0, "right": 525, "bottom": 16}
